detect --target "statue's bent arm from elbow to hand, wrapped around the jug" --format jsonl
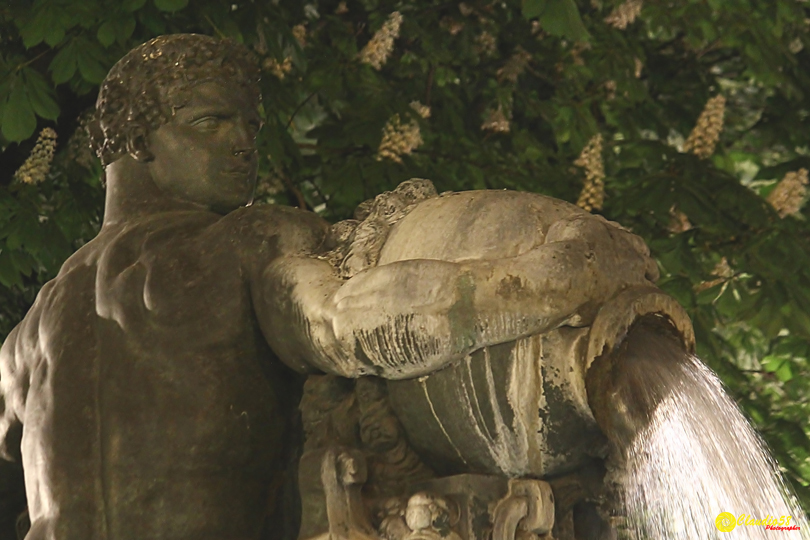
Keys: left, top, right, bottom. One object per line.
{"left": 253, "top": 216, "right": 656, "bottom": 378}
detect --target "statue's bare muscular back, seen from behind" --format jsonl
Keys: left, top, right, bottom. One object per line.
{"left": 16, "top": 205, "right": 326, "bottom": 540}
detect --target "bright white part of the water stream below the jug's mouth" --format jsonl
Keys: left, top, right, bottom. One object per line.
{"left": 625, "top": 356, "right": 810, "bottom": 540}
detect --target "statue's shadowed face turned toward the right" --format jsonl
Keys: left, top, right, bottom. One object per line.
{"left": 148, "top": 82, "right": 260, "bottom": 214}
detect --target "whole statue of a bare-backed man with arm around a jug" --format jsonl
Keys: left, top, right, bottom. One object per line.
{"left": 0, "top": 35, "right": 654, "bottom": 540}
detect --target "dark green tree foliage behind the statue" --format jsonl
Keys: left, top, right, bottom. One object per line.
{"left": 0, "top": 0, "right": 810, "bottom": 520}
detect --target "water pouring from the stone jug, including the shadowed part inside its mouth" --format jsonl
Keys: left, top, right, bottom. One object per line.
{"left": 589, "top": 325, "right": 810, "bottom": 540}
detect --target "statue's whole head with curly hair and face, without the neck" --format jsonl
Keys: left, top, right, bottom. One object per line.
{"left": 91, "top": 34, "right": 261, "bottom": 211}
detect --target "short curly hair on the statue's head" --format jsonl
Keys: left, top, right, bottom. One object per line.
{"left": 89, "top": 34, "right": 261, "bottom": 167}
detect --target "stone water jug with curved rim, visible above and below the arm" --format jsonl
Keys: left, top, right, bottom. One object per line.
{"left": 379, "top": 192, "right": 694, "bottom": 477}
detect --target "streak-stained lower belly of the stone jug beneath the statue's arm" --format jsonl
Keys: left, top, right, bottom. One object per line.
{"left": 389, "top": 322, "right": 605, "bottom": 477}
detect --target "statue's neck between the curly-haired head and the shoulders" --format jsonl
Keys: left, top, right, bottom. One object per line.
{"left": 102, "top": 156, "right": 204, "bottom": 227}
